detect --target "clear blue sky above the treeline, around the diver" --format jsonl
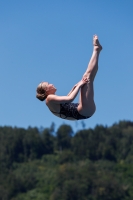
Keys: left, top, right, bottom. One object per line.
{"left": 0, "top": 0, "right": 133, "bottom": 130}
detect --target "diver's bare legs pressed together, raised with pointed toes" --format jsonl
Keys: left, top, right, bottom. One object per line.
{"left": 78, "top": 35, "right": 102, "bottom": 116}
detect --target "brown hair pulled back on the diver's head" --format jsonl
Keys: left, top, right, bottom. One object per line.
{"left": 36, "top": 82, "right": 47, "bottom": 101}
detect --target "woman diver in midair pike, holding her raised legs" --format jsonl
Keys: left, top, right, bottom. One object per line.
{"left": 36, "top": 35, "right": 102, "bottom": 120}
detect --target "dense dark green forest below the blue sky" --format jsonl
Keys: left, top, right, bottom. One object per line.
{"left": 0, "top": 121, "right": 133, "bottom": 200}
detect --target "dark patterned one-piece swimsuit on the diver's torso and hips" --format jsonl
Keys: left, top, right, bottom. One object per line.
{"left": 52, "top": 103, "right": 91, "bottom": 120}
